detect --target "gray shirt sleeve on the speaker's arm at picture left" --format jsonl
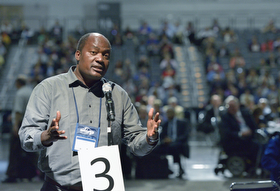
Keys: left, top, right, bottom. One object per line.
{"left": 19, "top": 84, "right": 51, "bottom": 152}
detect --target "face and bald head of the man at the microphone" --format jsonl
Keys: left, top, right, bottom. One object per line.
{"left": 75, "top": 34, "right": 111, "bottom": 81}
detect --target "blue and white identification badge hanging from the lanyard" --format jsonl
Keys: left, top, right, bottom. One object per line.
{"left": 72, "top": 123, "right": 100, "bottom": 152}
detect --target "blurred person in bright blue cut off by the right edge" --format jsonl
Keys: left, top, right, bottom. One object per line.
{"left": 261, "top": 134, "right": 280, "bottom": 185}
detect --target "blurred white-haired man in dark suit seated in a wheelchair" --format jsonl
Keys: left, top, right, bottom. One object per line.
{"left": 220, "top": 95, "right": 259, "bottom": 161}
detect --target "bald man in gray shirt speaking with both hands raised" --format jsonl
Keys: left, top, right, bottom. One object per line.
{"left": 19, "top": 33, "right": 161, "bottom": 191}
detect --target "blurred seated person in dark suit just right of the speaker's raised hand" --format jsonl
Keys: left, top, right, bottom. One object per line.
{"left": 153, "top": 107, "right": 190, "bottom": 178}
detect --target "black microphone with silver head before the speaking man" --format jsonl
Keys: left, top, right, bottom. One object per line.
{"left": 102, "top": 83, "right": 115, "bottom": 121}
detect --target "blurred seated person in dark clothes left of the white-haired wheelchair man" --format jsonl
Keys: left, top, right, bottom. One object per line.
{"left": 197, "top": 94, "right": 222, "bottom": 134}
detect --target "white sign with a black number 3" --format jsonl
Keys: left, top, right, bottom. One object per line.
{"left": 78, "top": 145, "right": 125, "bottom": 191}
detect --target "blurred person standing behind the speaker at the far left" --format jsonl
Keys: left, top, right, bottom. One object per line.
{"left": 2, "top": 75, "right": 38, "bottom": 183}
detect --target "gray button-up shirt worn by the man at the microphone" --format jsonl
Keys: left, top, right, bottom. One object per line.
{"left": 19, "top": 66, "right": 154, "bottom": 185}
